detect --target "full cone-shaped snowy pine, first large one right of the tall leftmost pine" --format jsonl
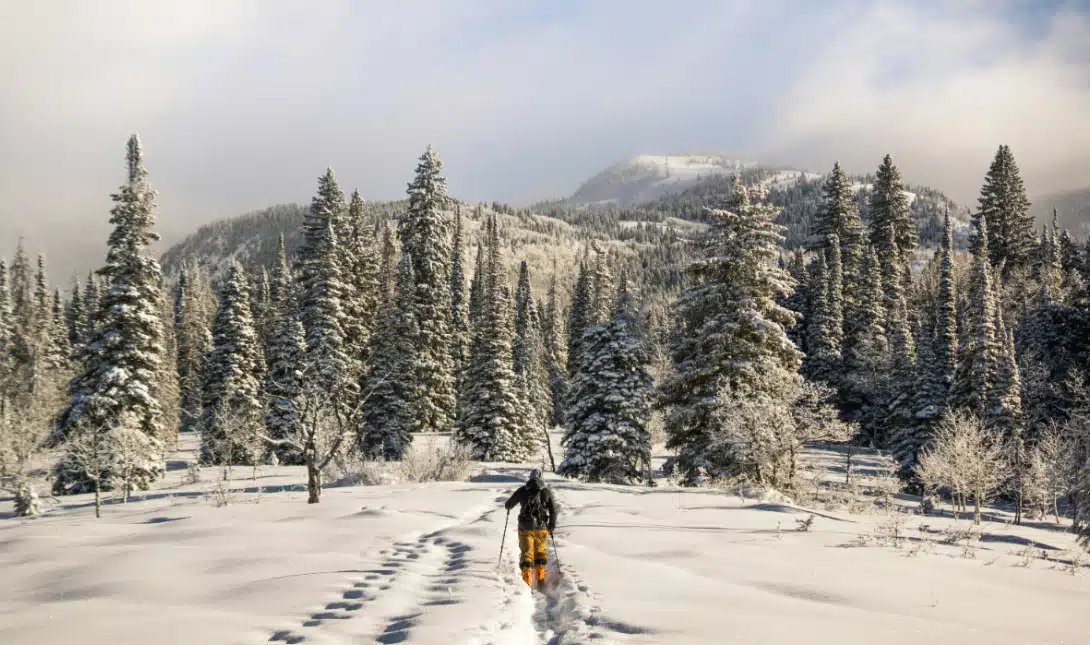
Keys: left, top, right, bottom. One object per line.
{"left": 201, "top": 263, "right": 265, "bottom": 465}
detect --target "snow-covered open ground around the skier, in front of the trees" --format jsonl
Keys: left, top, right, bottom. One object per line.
{"left": 0, "top": 435, "right": 1090, "bottom": 645}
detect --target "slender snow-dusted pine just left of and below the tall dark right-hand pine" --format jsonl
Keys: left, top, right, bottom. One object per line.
{"left": 950, "top": 211, "right": 998, "bottom": 414}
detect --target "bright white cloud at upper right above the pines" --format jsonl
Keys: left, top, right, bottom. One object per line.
{"left": 765, "top": 2, "right": 1090, "bottom": 205}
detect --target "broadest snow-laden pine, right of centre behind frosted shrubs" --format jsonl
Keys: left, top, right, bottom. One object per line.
{"left": 661, "top": 177, "right": 802, "bottom": 483}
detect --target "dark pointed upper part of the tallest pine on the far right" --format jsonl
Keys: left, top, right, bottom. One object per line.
{"left": 973, "top": 146, "right": 1036, "bottom": 276}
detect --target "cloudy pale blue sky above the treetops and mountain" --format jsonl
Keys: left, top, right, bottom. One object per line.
{"left": 0, "top": 0, "right": 1090, "bottom": 283}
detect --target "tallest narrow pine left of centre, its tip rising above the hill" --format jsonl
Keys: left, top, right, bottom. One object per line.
{"left": 398, "top": 146, "right": 457, "bottom": 433}
